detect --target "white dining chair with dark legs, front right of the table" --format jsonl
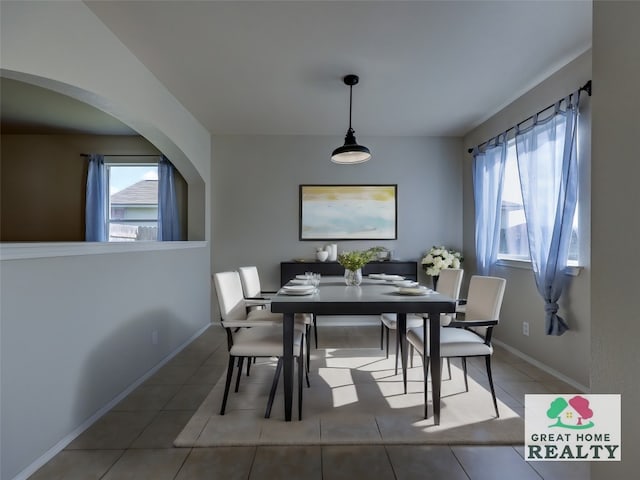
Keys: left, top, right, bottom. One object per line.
{"left": 407, "top": 275, "right": 506, "bottom": 417}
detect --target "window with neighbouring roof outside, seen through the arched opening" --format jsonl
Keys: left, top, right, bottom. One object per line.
{"left": 106, "top": 163, "right": 158, "bottom": 242}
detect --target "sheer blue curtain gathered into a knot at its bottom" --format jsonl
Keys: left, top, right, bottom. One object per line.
{"left": 516, "top": 91, "right": 580, "bottom": 335}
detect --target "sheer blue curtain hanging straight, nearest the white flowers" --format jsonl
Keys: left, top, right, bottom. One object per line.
{"left": 473, "top": 137, "right": 507, "bottom": 275}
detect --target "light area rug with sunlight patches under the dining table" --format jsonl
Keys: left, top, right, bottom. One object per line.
{"left": 174, "top": 348, "right": 524, "bottom": 447}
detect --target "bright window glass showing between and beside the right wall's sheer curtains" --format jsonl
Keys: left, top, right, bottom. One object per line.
{"left": 498, "top": 135, "right": 580, "bottom": 265}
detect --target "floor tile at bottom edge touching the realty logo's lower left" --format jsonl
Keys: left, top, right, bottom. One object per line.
{"left": 451, "top": 446, "right": 540, "bottom": 480}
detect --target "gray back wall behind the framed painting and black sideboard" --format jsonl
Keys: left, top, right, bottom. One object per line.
{"left": 211, "top": 136, "right": 462, "bottom": 289}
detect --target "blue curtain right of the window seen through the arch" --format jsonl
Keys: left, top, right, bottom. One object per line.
{"left": 158, "top": 155, "right": 181, "bottom": 241}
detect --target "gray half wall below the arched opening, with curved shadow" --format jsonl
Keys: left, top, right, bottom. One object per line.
{"left": 0, "top": 242, "right": 210, "bottom": 479}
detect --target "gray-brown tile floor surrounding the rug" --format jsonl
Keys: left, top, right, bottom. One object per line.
{"left": 30, "top": 325, "right": 590, "bottom": 480}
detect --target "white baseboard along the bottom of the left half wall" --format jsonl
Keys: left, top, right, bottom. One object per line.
{"left": 12, "top": 324, "right": 211, "bottom": 480}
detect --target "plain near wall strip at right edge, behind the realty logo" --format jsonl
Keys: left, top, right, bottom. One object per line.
{"left": 591, "top": 1, "right": 640, "bottom": 480}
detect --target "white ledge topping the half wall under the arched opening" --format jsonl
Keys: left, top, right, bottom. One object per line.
{"left": 0, "top": 241, "right": 208, "bottom": 260}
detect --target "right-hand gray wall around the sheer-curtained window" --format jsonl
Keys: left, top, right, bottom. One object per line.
{"left": 464, "top": 52, "right": 598, "bottom": 389}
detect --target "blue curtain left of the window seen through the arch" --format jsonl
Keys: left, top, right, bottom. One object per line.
{"left": 85, "top": 154, "right": 107, "bottom": 242}
